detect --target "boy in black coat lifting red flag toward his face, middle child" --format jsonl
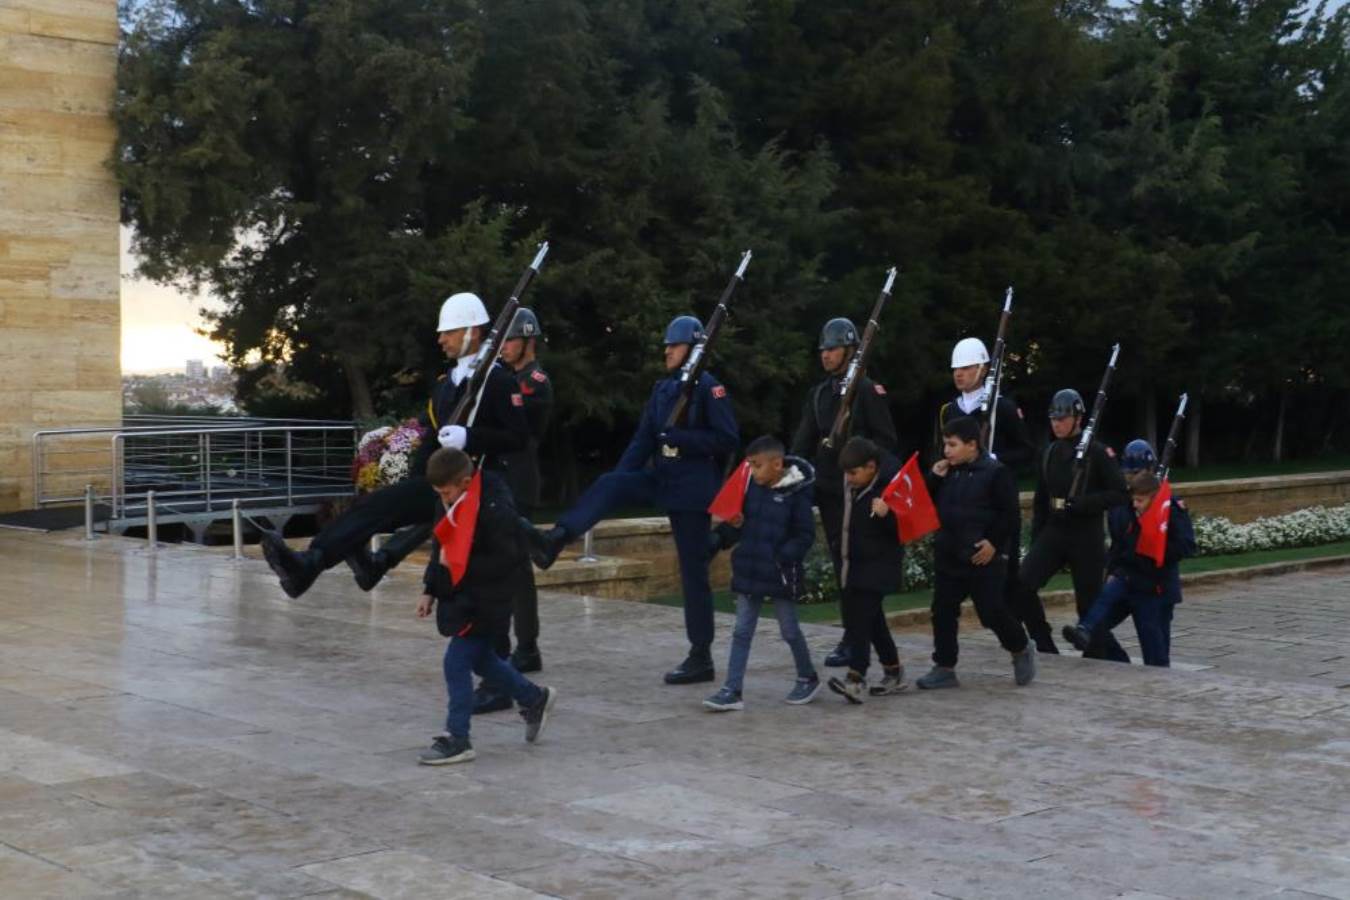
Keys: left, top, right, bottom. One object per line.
{"left": 829, "top": 437, "right": 907, "bottom": 704}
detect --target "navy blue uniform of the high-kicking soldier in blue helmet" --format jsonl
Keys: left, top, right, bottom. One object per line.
{"left": 558, "top": 372, "right": 740, "bottom": 648}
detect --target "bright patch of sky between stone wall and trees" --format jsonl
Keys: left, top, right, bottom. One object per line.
{"left": 122, "top": 228, "right": 223, "bottom": 375}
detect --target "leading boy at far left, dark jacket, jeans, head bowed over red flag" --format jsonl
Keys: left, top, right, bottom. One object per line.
{"left": 417, "top": 447, "right": 558, "bottom": 765}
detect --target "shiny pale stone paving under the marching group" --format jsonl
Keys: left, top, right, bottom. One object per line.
{"left": 0, "top": 533, "right": 1350, "bottom": 900}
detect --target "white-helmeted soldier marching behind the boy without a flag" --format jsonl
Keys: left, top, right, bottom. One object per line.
{"left": 936, "top": 337, "right": 1060, "bottom": 653}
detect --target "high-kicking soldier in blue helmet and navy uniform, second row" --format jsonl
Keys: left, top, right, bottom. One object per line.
{"left": 525, "top": 316, "right": 740, "bottom": 684}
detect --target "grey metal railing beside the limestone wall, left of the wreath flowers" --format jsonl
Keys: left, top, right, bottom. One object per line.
{"left": 32, "top": 417, "right": 358, "bottom": 530}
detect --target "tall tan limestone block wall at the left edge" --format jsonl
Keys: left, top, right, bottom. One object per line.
{"left": 0, "top": 0, "right": 122, "bottom": 510}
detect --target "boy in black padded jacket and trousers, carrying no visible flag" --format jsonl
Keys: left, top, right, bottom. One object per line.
{"left": 915, "top": 416, "right": 1035, "bottom": 691}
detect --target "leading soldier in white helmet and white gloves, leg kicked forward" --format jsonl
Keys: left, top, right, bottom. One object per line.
{"left": 262, "top": 293, "right": 529, "bottom": 598}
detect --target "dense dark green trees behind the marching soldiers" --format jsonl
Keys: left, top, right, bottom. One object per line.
{"left": 113, "top": 0, "right": 1350, "bottom": 499}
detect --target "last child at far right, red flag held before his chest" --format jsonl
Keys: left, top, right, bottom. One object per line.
{"left": 1064, "top": 470, "right": 1195, "bottom": 668}
